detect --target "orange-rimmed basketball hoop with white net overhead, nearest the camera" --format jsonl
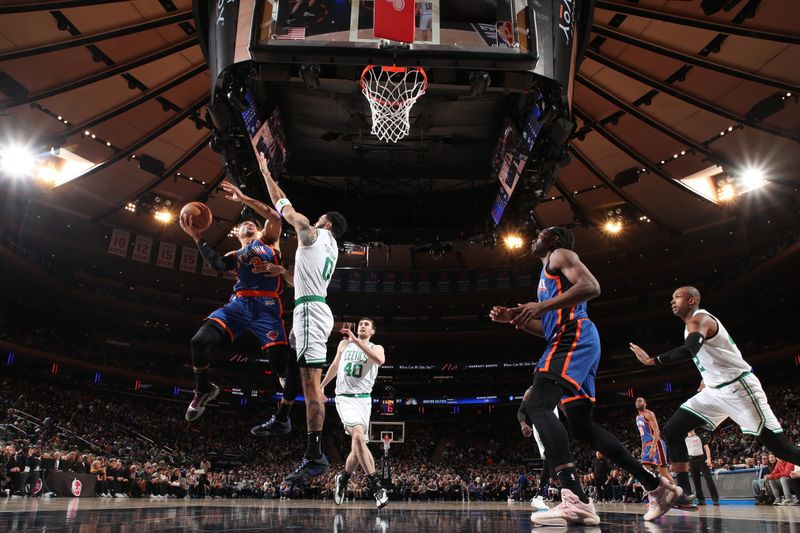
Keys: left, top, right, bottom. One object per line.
{"left": 361, "top": 65, "right": 428, "bottom": 143}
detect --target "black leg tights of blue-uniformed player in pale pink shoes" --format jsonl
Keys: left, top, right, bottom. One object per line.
{"left": 527, "top": 374, "right": 658, "bottom": 490}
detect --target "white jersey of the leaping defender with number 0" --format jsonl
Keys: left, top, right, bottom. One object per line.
{"left": 294, "top": 228, "right": 339, "bottom": 300}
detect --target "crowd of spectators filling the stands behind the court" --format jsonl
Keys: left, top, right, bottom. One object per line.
{"left": 0, "top": 370, "right": 800, "bottom": 503}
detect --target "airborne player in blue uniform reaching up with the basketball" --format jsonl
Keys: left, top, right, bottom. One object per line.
{"left": 180, "top": 182, "right": 300, "bottom": 422}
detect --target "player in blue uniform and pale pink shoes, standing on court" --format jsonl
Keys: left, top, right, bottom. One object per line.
{"left": 489, "top": 227, "right": 681, "bottom": 526}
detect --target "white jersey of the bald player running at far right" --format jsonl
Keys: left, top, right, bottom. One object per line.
{"left": 683, "top": 309, "right": 752, "bottom": 387}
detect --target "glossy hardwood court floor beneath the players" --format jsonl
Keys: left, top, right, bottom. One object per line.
{"left": 0, "top": 498, "right": 800, "bottom": 533}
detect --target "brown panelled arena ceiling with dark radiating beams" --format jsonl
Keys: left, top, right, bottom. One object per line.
{"left": 0, "top": 0, "right": 800, "bottom": 256}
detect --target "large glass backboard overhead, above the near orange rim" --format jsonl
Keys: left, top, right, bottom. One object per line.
{"left": 250, "top": 0, "right": 537, "bottom": 70}
